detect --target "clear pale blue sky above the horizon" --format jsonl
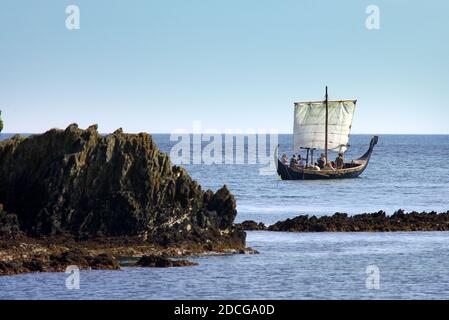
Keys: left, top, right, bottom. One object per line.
{"left": 0, "top": 0, "right": 449, "bottom": 133}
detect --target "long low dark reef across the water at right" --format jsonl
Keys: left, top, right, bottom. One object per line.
{"left": 237, "top": 210, "right": 449, "bottom": 232}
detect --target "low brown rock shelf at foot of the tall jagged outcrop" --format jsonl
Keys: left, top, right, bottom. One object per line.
{"left": 0, "top": 236, "right": 257, "bottom": 276}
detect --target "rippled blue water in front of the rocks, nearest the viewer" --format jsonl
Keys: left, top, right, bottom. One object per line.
{"left": 0, "top": 232, "right": 449, "bottom": 299}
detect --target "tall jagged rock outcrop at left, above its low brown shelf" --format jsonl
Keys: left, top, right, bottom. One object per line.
{"left": 0, "top": 124, "right": 245, "bottom": 250}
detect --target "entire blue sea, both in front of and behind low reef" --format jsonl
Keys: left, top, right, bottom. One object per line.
{"left": 0, "top": 134, "right": 449, "bottom": 300}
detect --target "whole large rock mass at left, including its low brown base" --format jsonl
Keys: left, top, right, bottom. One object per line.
{"left": 0, "top": 124, "right": 254, "bottom": 275}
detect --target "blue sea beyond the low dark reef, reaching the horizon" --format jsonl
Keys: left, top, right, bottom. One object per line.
{"left": 163, "top": 135, "right": 449, "bottom": 224}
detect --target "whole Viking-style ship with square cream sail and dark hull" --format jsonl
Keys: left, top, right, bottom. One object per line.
{"left": 275, "top": 87, "right": 378, "bottom": 180}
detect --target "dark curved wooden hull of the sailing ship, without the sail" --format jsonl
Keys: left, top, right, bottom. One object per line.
{"left": 277, "top": 136, "right": 378, "bottom": 180}
